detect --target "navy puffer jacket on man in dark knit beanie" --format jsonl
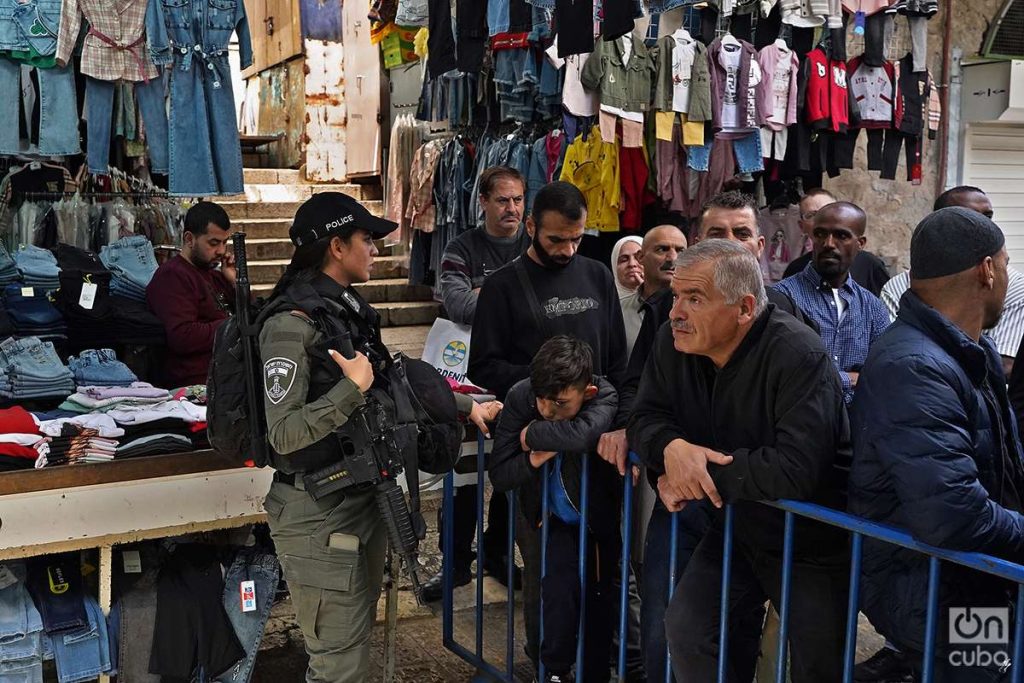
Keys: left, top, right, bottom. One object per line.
{"left": 850, "top": 291, "right": 1024, "bottom": 652}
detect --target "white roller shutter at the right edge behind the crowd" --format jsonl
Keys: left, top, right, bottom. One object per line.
{"left": 964, "top": 123, "right": 1024, "bottom": 269}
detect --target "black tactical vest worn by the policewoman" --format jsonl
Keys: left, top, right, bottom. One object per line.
{"left": 267, "top": 280, "right": 389, "bottom": 474}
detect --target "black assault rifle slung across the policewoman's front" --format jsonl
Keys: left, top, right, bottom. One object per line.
{"left": 302, "top": 330, "right": 423, "bottom": 604}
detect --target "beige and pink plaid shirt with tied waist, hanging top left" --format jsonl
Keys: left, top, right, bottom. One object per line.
{"left": 57, "top": 0, "right": 160, "bottom": 81}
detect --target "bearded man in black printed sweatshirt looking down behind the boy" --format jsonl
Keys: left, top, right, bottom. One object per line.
{"left": 469, "top": 181, "right": 626, "bottom": 663}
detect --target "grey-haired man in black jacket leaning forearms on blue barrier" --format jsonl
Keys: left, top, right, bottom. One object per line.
{"left": 629, "top": 240, "right": 849, "bottom": 683}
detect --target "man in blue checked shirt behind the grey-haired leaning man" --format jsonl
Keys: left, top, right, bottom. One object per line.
{"left": 775, "top": 202, "right": 889, "bottom": 403}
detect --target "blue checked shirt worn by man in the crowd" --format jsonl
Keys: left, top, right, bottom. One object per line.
{"left": 775, "top": 263, "right": 889, "bottom": 403}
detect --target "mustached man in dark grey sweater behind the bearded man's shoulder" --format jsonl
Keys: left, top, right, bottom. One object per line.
{"left": 423, "top": 166, "right": 529, "bottom": 602}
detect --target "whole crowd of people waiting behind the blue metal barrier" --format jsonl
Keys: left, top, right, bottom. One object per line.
{"left": 437, "top": 168, "right": 1024, "bottom": 683}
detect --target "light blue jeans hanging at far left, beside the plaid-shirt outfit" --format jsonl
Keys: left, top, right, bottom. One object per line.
{"left": 0, "top": 57, "right": 82, "bottom": 157}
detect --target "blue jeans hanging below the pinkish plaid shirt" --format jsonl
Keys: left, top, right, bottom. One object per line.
{"left": 85, "top": 76, "right": 168, "bottom": 175}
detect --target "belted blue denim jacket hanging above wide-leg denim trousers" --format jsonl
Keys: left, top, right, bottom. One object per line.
{"left": 145, "top": 0, "right": 253, "bottom": 71}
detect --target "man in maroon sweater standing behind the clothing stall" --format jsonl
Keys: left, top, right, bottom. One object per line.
{"left": 145, "top": 202, "right": 236, "bottom": 387}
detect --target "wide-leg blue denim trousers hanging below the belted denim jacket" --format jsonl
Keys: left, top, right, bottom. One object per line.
{"left": 168, "top": 47, "right": 245, "bottom": 197}
